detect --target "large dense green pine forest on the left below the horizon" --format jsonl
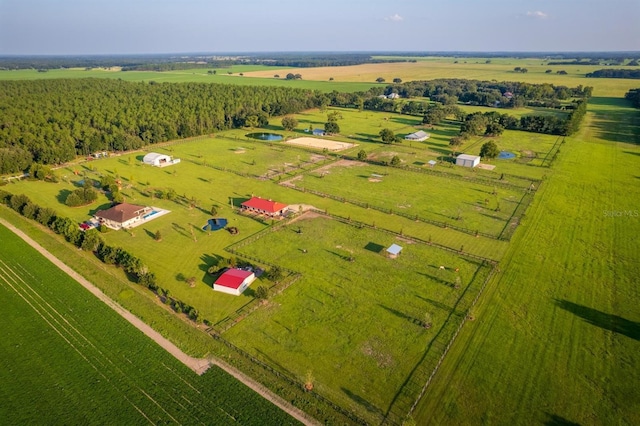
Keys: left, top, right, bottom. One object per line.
{"left": 0, "top": 79, "right": 321, "bottom": 173}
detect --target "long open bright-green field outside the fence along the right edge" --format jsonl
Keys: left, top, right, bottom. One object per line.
{"left": 415, "top": 98, "right": 640, "bottom": 425}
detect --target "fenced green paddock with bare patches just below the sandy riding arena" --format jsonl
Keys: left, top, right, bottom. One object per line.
{"left": 293, "top": 163, "right": 524, "bottom": 237}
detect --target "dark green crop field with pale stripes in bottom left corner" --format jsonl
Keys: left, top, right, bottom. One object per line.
{"left": 0, "top": 226, "right": 297, "bottom": 425}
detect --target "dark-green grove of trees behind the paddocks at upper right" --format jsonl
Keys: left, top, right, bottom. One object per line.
{"left": 384, "top": 79, "right": 593, "bottom": 108}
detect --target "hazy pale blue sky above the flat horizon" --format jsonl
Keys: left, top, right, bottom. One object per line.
{"left": 0, "top": 0, "right": 640, "bottom": 55}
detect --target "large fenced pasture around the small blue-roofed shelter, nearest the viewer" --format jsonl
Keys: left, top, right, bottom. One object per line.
{"left": 224, "top": 217, "right": 488, "bottom": 423}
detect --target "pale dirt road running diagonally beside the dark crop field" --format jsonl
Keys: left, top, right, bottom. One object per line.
{"left": 0, "top": 218, "right": 320, "bottom": 425}
